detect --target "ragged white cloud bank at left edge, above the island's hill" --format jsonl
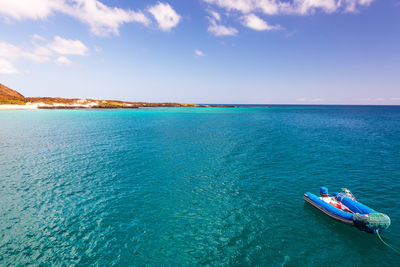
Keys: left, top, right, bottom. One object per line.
{"left": 0, "top": 35, "right": 89, "bottom": 74}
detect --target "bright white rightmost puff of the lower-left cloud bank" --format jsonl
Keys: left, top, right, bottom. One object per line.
{"left": 48, "top": 36, "right": 89, "bottom": 56}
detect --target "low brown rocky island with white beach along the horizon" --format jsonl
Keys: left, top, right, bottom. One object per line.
{"left": 0, "top": 83, "right": 231, "bottom": 109}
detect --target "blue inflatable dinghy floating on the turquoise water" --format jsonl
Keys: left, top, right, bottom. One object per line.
{"left": 304, "top": 187, "right": 390, "bottom": 233}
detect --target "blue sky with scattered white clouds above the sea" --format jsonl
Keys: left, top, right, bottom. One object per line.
{"left": 0, "top": 0, "right": 400, "bottom": 105}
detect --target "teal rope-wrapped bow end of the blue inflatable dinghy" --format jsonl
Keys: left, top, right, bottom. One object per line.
{"left": 353, "top": 212, "right": 390, "bottom": 233}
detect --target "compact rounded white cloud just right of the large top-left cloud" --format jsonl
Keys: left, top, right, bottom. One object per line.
{"left": 148, "top": 2, "right": 181, "bottom": 31}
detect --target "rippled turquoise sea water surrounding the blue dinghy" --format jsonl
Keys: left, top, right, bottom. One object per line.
{"left": 0, "top": 106, "right": 400, "bottom": 266}
